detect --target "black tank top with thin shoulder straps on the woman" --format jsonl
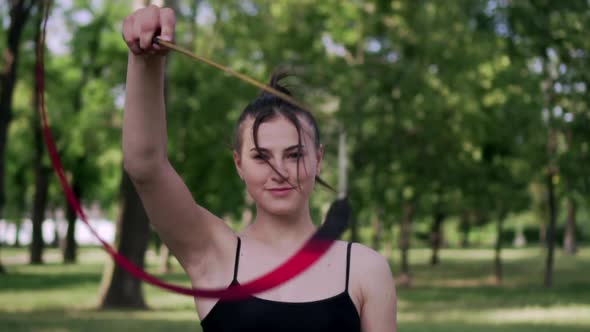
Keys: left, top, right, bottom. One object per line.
{"left": 201, "top": 238, "right": 361, "bottom": 332}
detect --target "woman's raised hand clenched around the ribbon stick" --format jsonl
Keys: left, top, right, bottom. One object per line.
{"left": 123, "top": 5, "right": 176, "bottom": 55}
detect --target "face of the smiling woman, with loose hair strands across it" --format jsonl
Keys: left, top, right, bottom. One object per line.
{"left": 234, "top": 115, "right": 323, "bottom": 216}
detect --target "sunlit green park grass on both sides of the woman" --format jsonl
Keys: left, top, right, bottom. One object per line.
{"left": 0, "top": 248, "right": 590, "bottom": 332}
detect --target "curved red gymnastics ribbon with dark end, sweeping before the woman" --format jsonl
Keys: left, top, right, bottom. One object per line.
{"left": 36, "top": 0, "right": 350, "bottom": 300}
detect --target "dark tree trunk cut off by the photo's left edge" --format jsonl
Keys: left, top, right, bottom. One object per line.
{"left": 0, "top": 0, "right": 36, "bottom": 271}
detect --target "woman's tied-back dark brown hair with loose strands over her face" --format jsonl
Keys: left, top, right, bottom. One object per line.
{"left": 233, "top": 70, "right": 335, "bottom": 191}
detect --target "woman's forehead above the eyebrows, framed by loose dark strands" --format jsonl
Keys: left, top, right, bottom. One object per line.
{"left": 242, "top": 115, "right": 313, "bottom": 149}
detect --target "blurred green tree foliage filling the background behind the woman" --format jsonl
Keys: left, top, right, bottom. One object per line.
{"left": 0, "top": 0, "right": 590, "bottom": 249}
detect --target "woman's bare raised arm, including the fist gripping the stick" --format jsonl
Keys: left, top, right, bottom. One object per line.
{"left": 123, "top": 6, "right": 235, "bottom": 278}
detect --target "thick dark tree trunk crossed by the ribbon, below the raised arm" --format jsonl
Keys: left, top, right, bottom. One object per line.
{"left": 100, "top": 172, "right": 150, "bottom": 308}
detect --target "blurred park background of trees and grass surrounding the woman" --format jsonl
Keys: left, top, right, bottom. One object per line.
{"left": 0, "top": 0, "right": 590, "bottom": 332}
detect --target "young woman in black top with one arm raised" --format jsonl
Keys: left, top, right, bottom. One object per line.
{"left": 123, "top": 6, "right": 396, "bottom": 332}
